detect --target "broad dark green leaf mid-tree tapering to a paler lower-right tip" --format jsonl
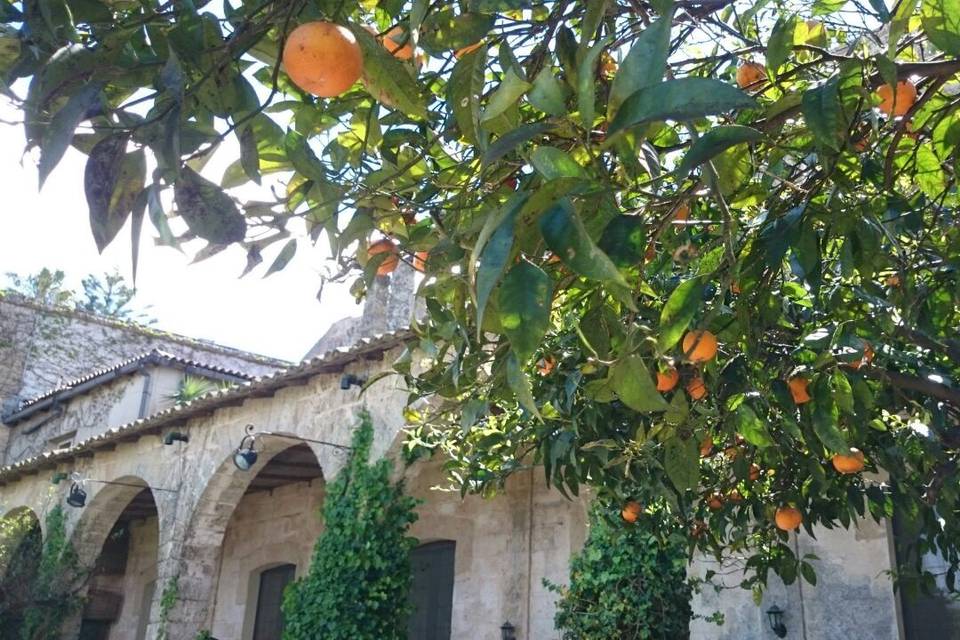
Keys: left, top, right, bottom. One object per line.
{"left": 540, "top": 198, "right": 634, "bottom": 308}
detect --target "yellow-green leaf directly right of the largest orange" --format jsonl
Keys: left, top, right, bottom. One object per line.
{"left": 350, "top": 25, "right": 427, "bottom": 118}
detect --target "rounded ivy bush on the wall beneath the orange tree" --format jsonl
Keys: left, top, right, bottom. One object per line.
{"left": 548, "top": 502, "right": 693, "bottom": 640}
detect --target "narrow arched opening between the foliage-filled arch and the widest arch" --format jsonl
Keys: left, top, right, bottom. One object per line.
{"left": 77, "top": 478, "right": 159, "bottom": 640}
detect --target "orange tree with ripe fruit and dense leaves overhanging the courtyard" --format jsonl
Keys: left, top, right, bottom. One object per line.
{"left": 0, "top": 0, "right": 960, "bottom": 600}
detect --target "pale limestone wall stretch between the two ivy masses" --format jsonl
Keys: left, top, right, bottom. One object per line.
{"left": 406, "top": 462, "right": 586, "bottom": 640}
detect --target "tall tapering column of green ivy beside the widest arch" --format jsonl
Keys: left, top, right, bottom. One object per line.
{"left": 283, "top": 414, "right": 417, "bottom": 640}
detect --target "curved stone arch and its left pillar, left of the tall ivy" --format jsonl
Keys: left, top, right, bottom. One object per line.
{"left": 168, "top": 431, "right": 328, "bottom": 637}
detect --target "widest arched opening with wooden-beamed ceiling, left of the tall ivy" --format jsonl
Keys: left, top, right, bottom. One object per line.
{"left": 187, "top": 439, "right": 324, "bottom": 640}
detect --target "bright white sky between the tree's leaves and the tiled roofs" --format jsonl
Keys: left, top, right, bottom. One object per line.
{"left": 0, "top": 104, "right": 361, "bottom": 360}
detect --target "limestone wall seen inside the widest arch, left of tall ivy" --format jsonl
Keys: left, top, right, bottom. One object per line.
{"left": 212, "top": 478, "right": 324, "bottom": 640}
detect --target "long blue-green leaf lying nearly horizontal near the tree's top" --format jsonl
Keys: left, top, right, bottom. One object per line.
{"left": 609, "top": 78, "right": 757, "bottom": 135}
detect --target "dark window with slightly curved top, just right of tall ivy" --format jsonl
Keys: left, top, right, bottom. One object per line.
{"left": 407, "top": 540, "right": 457, "bottom": 640}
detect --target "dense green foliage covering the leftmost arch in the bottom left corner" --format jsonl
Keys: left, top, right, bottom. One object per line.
{"left": 0, "top": 505, "right": 88, "bottom": 640}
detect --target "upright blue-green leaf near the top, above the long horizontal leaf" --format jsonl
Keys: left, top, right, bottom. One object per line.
{"left": 607, "top": 12, "right": 672, "bottom": 120}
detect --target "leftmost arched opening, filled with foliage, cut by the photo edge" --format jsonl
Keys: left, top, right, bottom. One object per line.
{"left": 0, "top": 507, "right": 43, "bottom": 639}
